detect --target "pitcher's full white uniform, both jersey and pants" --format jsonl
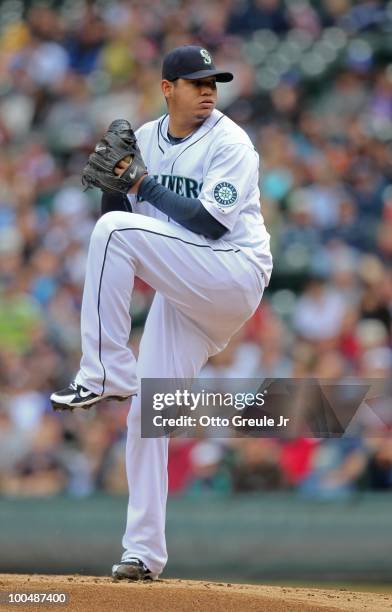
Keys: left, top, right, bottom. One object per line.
{"left": 76, "top": 111, "right": 272, "bottom": 575}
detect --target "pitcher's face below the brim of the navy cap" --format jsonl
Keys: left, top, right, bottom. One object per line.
{"left": 164, "top": 77, "right": 217, "bottom": 123}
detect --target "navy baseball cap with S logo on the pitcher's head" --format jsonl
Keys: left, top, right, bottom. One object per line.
{"left": 162, "top": 45, "right": 233, "bottom": 83}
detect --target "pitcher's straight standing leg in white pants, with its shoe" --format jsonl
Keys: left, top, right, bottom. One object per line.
{"left": 113, "top": 294, "right": 213, "bottom": 580}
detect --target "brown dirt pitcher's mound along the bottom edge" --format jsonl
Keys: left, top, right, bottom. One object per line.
{"left": 0, "top": 574, "right": 392, "bottom": 612}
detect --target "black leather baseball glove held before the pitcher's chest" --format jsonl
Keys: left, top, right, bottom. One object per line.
{"left": 82, "top": 119, "right": 147, "bottom": 194}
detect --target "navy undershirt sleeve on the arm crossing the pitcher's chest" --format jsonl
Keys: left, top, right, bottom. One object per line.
{"left": 137, "top": 176, "right": 227, "bottom": 240}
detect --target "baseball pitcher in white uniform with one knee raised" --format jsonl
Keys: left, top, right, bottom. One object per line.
{"left": 51, "top": 45, "right": 272, "bottom": 580}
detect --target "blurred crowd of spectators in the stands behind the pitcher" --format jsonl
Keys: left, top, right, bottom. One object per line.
{"left": 0, "top": 0, "right": 392, "bottom": 498}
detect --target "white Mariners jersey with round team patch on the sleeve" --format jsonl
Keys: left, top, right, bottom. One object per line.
{"left": 129, "top": 110, "right": 272, "bottom": 285}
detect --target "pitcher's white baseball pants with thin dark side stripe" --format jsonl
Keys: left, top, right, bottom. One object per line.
{"left": 76, "top": 212, "right": 263, "bottom": 575}
